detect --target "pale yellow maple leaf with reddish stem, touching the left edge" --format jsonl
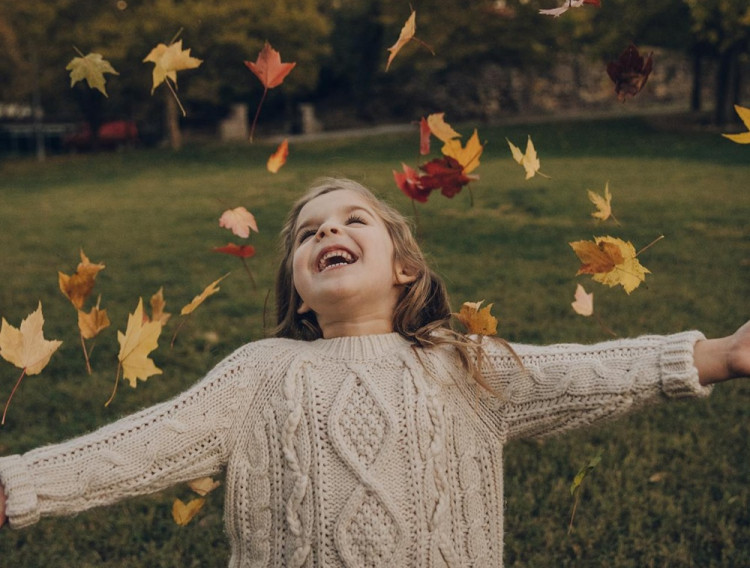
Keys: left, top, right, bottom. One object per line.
{"left": 0, "top": 302, "right": 62, "bottom": 424}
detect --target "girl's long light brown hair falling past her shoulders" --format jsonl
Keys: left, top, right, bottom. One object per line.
{"left": 273, "top": 178, "right": 507, "bottom": 390}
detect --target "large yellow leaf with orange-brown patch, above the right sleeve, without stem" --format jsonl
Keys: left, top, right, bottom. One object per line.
{"left": 569, "top": 237, "right": 650, "bottom": 294}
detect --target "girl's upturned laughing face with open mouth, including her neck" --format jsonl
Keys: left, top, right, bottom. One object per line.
{"left": 292, "top": 189, "right": 412, "bottom": 337}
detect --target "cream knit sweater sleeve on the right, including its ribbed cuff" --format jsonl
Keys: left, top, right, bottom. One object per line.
{"left": 472, "top": 331, "right": 711, "bottom": 441}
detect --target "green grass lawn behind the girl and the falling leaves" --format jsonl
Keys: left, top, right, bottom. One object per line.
{"left": 0, "top": 113, "right": 750, "bottom": 567}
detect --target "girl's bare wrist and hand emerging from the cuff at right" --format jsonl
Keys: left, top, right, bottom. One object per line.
{"left": 693, "top": 321, "right": 750, "bottom": 385}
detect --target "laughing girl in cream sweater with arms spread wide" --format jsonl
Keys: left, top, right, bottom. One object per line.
{"left": 0, "top": 179, "right": 750, "bottom": 567}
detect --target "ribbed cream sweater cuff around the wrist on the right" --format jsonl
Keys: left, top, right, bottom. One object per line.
{"left": 660, "top": 331, "right": 712, "bottom": 398}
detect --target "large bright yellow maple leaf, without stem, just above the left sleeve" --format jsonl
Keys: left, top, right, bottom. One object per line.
{"left": 117, "top": 298, "right": 162, "bottom": 388}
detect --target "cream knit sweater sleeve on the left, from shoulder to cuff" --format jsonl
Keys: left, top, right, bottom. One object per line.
{"left": 0, "top": 340, "right": 262, "bottom": 528}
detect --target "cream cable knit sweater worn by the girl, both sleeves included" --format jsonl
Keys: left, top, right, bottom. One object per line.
{"left": 0, "top": 332, "right": 709, "bottom": 567}
